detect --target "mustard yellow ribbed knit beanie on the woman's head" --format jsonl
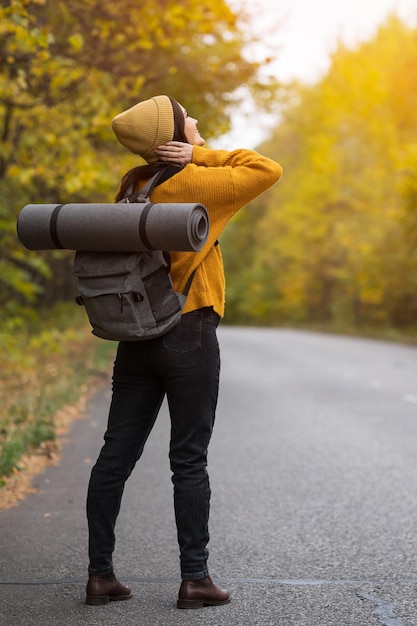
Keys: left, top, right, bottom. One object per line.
{"left": 112, "top": 96, "right": 174, "bottom": 163}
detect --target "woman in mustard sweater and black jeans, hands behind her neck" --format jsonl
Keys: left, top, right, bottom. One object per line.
{"left": 86, "top": 96, "right": 281, "bottom": 608}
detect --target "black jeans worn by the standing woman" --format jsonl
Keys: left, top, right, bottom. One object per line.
{"left": 87, "top": 307, "right": 220, "bottom": 579}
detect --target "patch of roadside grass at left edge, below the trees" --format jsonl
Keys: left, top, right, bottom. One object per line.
{"left": 0, "top": 305, "right": 116, "bottom": 480}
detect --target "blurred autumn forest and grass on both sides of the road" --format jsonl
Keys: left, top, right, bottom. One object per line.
{"left": 0, "top": 0, "right": 417, "bottom": 476}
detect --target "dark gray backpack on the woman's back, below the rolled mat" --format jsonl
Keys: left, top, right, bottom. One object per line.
{"left": 74, "top": 170, "right": 195, "bottom": 341}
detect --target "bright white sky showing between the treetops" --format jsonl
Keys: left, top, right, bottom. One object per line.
{"left": 213, "top": 0, "right": 417, "bottom": 149}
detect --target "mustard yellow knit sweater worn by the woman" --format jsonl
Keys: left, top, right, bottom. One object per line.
{"left": 151, "top": 146, "right": 282, "bottom": 317}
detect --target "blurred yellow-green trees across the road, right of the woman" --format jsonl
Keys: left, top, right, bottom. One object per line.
{"left": 225, "top": 16, "right": 417, "bottom": 329}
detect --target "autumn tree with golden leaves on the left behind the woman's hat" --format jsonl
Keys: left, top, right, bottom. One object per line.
{"left": 0, "top": 0, "right": 275, "bottom": 322}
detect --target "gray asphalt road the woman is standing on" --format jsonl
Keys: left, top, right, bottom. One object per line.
{"left": 0, "top": 327, "right": 417, "bottom": 626}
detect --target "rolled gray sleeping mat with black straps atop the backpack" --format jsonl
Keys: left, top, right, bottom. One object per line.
{"left": 17, "top": 203, "right": 210, "bottom": 252}
